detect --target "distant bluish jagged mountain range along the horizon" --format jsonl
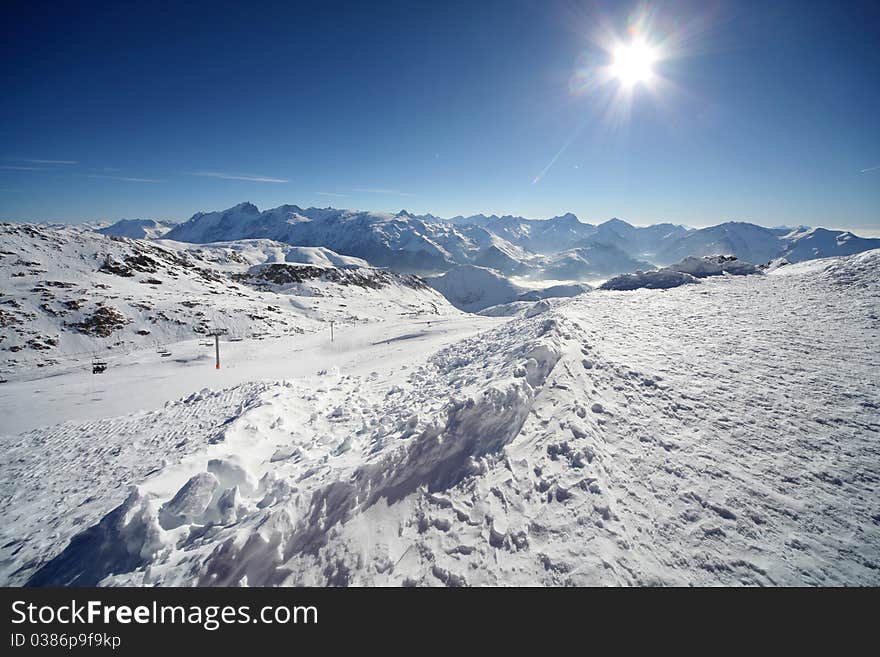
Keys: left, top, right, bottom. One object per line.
{"left": 165, "top": 203, "right": 880, "bottom": 280}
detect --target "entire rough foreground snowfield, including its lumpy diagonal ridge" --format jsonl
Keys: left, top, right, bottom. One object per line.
{"left": 0, "top": 251, "right": 880, "bottom": 586}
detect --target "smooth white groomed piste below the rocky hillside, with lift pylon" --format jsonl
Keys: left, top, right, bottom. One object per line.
{"left": 0, "top": 316, "right": 496, "bottom": 434}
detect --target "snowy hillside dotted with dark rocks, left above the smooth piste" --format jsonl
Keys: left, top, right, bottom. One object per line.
{"left": 0, "top": 224, "right": 457, "bottom": 377}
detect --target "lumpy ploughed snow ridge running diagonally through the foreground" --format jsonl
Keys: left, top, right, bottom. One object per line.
{"left": 24, "top": 315, "right": 564, "bottom": 585}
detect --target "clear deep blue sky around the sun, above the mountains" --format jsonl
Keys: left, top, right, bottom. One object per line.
{"left": 0, "top": 0, "right": 880, "bottom": 234}
